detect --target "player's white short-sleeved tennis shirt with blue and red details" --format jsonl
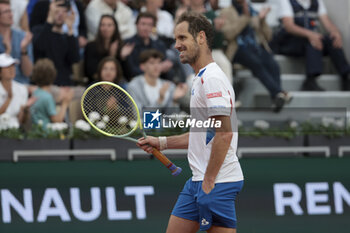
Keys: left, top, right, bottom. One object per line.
{"left": 188, "top": 62, "right": 243, "bottom": 183}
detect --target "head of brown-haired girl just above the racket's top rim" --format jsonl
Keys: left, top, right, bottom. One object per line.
{"left": 97, "top": 57, "right": 126, "bottom": 88}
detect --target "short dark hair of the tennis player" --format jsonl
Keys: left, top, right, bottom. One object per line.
{"left": 176, "top": 11, "right": 214, "bottom": 50}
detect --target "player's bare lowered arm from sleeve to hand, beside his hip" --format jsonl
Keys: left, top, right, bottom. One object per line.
{"left": 202, "top": 116, "right": 233, "bottom": 194}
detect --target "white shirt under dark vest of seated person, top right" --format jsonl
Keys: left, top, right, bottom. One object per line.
{"left": 279, "top": 0, "right": 327, "bottom": 18}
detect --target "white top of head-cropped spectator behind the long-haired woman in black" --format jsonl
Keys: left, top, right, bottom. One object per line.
{"left": 85, "top": 0, "right": 136, "bottom": 40}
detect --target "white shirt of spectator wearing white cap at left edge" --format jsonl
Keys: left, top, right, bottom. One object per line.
{"left": 0, "top": 81, "right": 28, "bottom": 127}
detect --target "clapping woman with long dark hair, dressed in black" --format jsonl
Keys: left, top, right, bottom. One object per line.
{"left": 84, "top": 15, "right": 134, "bottom": 84}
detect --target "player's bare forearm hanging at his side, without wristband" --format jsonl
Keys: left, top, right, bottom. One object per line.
{"left": 204, "top": 132, "right": 233, "bottom": 182}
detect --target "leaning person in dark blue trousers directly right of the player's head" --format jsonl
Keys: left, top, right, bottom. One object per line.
{"left": 221, "top": 0, "right": 291, "bottom": 112}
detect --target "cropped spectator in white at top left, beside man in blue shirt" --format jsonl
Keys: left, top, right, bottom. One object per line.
{"left": 10, "top": 0, "right": 29, "bottom": 31}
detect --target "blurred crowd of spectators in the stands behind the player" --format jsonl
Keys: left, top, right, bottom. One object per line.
{"left": 0, "top": 0, "right": 350, "bottom": 131}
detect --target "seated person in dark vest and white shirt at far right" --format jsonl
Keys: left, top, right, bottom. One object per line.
{"left": 272, "top": 0, "right": 350, "bottom": 91}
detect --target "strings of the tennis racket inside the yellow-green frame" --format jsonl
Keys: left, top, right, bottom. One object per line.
{"left": 83, "top": 84, "right": 138, "bottom": 136}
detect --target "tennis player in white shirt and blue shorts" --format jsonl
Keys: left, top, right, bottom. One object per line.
{"left": 138, "top": 13, "right": 243, "bottom": 233}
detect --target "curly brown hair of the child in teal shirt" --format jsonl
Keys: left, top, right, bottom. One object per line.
{"left": 32, "top": 58, "right": 57, "bottom": 87}
